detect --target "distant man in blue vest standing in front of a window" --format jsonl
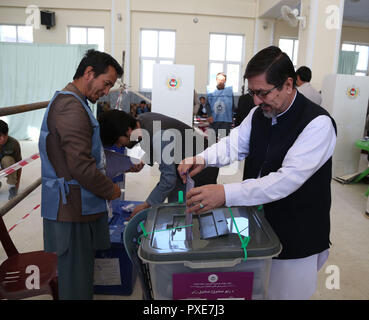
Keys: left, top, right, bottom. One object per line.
{"left": 207, "top": 72, "right": 234, "bottom": 137}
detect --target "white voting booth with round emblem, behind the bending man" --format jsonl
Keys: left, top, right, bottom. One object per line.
{"left": 151, "top": 64, "right": 195, "bottom": 127}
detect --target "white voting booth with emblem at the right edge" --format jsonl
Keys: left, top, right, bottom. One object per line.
{"left": 322, "top": 74, "right": 369, "bottom": 177}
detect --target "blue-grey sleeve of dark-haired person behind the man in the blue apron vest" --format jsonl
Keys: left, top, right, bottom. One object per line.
{"left": 104, "top": 149, "right": 140, "bottom": 179}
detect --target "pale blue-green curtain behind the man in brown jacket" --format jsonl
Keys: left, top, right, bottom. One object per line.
{"left": 0, "top": 42, "right": 97, "bottom": 140}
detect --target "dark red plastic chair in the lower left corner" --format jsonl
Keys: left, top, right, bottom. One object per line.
{"left": 0, "top": 216, "right": 58, "bottom": 300}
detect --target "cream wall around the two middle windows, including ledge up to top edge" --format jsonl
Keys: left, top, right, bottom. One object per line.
{"left": 130, "top": 0, "right": 256, "bottom": 93}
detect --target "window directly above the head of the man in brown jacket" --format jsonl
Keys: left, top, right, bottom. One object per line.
{"left": 68, "top": 27, "right": 104, "bottom": 51}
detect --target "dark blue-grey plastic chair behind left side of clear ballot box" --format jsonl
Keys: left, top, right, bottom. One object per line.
{"left": 123, "top": 209, "right": 152, "bottom": 300}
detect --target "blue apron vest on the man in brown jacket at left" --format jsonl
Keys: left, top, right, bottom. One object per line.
{"left": 38, "top": 91, "right": 107, "bottom": 220}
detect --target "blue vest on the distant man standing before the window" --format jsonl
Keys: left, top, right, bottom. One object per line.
{"left": 208, "top": 87, "right": 233, "bottom": 122}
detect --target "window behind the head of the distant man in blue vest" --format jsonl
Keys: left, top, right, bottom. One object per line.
{"left": 209, "top": 33, "right": 244, "bottom": 92}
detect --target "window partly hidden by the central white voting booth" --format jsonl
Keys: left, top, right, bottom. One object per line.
{"left": 140, "top": 30, "right": 176, "bottom": 91}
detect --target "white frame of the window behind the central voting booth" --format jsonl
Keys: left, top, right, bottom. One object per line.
{"left": 138, "top": 28, "right": 177, "bottom": 92}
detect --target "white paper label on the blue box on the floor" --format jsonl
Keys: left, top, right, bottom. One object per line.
{"left": 94, "top": 258, "right": 122, "bottom": 286}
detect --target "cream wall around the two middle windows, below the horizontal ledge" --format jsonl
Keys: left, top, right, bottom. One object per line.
{"left": 131, "top": 12, "right": 254, "bottom": 93}
